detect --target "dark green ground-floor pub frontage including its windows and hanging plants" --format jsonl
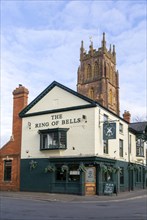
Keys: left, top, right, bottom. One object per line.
{"left": 20, "top": 157, "right": 146, "bottom": 195}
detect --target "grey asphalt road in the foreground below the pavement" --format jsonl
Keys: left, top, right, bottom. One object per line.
{"left": 0, "top": 197, "right": 147, "bottom": 220}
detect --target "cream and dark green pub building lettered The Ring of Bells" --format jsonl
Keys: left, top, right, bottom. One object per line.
{"left": 20, "top": 81, "right": 147, "bottom": 195}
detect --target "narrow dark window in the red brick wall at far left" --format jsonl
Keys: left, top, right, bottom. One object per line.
{"left": 4, "top": 160, "right": 12, "bottom": 181}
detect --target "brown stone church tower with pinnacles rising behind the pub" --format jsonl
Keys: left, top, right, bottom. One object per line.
{"left": 77, "top": 33, "right": 120, "bottom": 115}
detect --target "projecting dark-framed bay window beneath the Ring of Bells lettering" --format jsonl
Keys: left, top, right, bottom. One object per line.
{"left": 40, "top": 128, "right": 68, "bottom": 150}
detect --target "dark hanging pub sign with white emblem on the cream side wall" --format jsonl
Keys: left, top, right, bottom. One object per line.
{"left": 103, "top": 122, "right": 116, "bottom": 140}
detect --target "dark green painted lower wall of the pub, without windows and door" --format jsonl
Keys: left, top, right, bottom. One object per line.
{"left": 20, "top": 157, "right": 146, "bottom": 195}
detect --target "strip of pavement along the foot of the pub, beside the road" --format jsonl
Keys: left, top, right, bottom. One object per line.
{"left": 0, "top": 189, "right": 147, "bottom": 203}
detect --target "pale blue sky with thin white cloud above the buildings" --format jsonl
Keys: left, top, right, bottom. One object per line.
{"left": 0, "top": 0, "right": 147, "bottom": 146}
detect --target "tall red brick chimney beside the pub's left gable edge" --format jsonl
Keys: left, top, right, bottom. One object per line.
{"left": 12, "top": 84, "right": 29, "bottom": 146}
